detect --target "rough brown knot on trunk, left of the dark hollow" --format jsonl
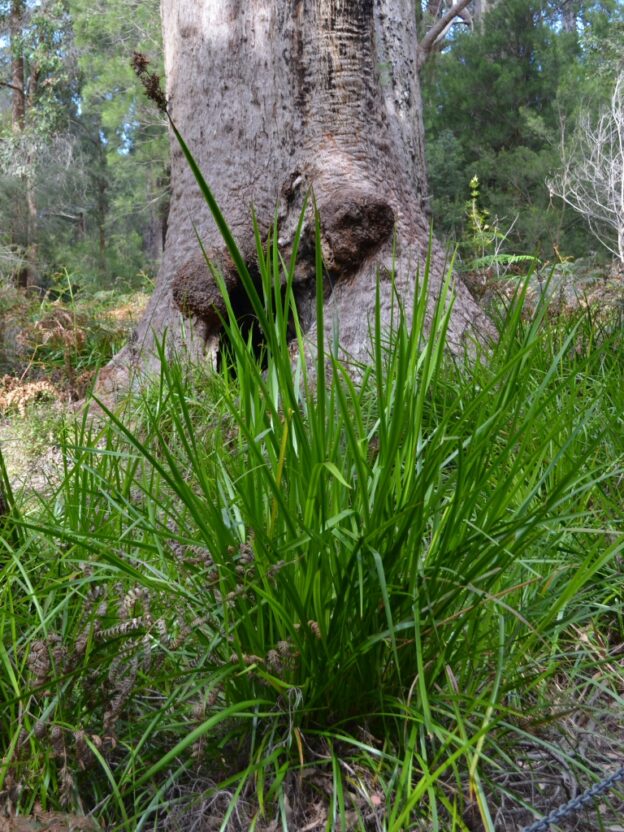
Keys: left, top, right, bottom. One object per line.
{"left": 172, "top": 251, "right": 238, "bottom": 329}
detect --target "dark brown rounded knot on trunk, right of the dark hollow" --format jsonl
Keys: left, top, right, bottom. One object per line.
{"left": 319, "top": 191, "right": 395, "bottom": 276}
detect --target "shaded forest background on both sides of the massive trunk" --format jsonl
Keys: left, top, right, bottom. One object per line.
{"left": 0, "top": 0, "right": 624, "bottom": 300}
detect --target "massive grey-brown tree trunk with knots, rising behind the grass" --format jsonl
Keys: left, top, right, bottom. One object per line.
{"left": 103, "top": 0, "right": 488, "bottom": 394}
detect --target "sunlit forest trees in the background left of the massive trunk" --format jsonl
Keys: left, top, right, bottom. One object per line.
{"left": 0, "top": 0, "right": 168, "bottom": 286}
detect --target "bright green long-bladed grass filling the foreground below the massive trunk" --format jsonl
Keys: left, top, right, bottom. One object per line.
{"left": 0, "top": 159, "right": 624, "bottom": 832}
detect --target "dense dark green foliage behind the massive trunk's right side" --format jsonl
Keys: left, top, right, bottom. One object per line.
{"left": 423, "top": 0, "right": 621, "bottom": 257}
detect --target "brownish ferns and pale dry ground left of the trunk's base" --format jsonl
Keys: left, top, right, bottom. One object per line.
{"left": 0, "top": 287, "right": 148, "bottom": 493}
